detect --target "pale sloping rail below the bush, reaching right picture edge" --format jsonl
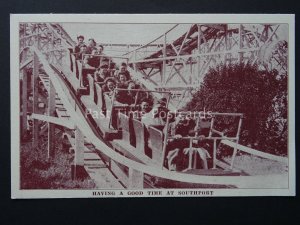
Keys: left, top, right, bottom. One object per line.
{"left": 221, "top": 140, "right": 288, "bottom": 164}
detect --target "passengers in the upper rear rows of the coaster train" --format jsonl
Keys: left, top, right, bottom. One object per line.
{"left": 73, "top": 35, "right": 152, "bottom": 105}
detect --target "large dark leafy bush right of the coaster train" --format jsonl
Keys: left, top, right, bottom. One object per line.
{"left": 186, "top": 64, "right": 287, "bottom": 155}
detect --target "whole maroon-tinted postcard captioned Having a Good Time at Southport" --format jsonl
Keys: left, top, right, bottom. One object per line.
{"left": 10, "top": 14, "right": 295, "bottom": 198}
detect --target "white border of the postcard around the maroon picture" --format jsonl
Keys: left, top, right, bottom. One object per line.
{"left": 10, "top": 14, "right": 296, "bottom": 199}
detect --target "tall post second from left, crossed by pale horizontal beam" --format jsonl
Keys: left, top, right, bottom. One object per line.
{"left": 32, "top": 53, "right": 39, "bottom": 149}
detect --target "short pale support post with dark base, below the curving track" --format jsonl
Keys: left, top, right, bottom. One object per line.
{"left": 71, "top": 127, "right": 87, "bottom": 179}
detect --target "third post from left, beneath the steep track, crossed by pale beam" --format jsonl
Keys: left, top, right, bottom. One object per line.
{"left": 47, "top": 80, "right": 55, "bottom": 160}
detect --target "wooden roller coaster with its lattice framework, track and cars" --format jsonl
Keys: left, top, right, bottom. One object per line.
{"left": 20, "top": 23, "right": 288, "bottom": 189}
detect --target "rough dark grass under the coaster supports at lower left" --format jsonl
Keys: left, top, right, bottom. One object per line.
{"left": 20, "top": 131, "right": 96, "bottom": 189}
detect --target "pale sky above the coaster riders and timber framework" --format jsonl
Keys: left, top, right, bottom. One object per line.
{"left": 61, "top": 21, "right": 288, "bottom": 58}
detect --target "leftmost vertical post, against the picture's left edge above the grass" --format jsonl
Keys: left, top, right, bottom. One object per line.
{"left": 21, "top": 68, "right": 28, "bottom": 136}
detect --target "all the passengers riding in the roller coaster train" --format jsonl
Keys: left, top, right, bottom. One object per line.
{"left": 73, "top": 35, "right": 212, "bottom": 170}
